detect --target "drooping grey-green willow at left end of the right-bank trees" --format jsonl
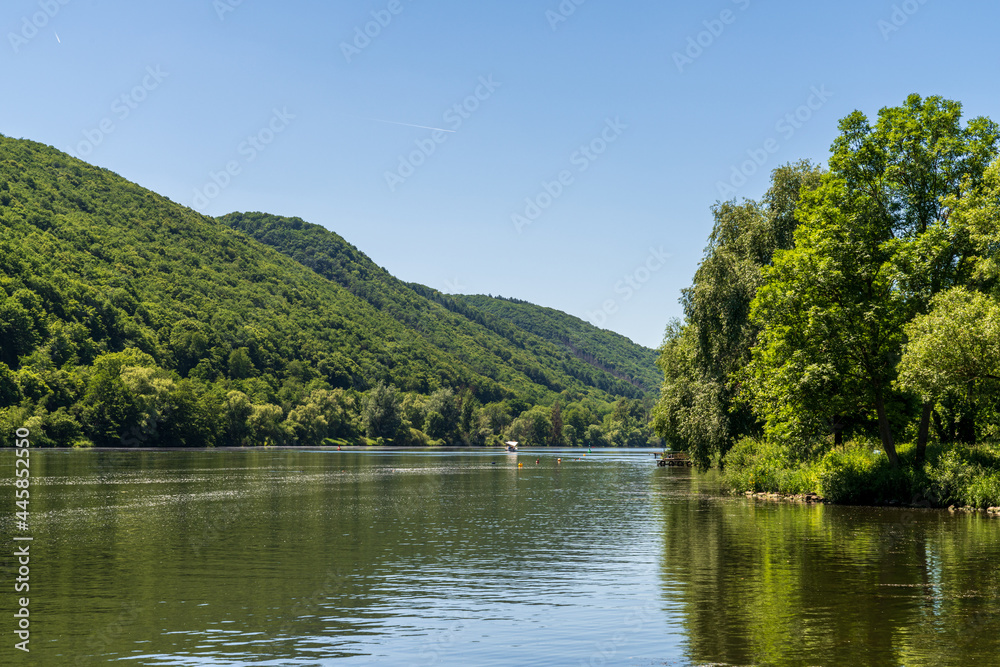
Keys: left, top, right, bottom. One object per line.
{"left": 653, "top": 161, "right": 821, "bottom": 467}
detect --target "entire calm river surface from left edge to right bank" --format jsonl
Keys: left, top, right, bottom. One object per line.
{"left": 0, "top": 450, "right": 1000, "bottom": 667}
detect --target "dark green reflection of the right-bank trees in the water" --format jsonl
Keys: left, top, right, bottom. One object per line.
{"left": 660, "top": 473, "right": 1000, "bottom": 665}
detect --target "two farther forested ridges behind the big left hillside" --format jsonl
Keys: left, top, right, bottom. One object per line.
{"left": 220, "top": 213, "right": 660, "bottom": 397}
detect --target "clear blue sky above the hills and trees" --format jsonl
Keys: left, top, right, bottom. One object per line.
{"left": 0, "top": 0, "right": 1000, "bottom": 347}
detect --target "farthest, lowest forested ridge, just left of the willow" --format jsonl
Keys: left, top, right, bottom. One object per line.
{"left": 452, "top": 295, "right": 663, "bottom": 393}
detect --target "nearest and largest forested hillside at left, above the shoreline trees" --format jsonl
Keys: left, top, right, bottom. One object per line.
{"left": 0, "top": 138, "right": 503, "bottom": 393}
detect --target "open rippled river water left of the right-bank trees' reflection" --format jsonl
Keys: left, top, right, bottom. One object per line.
{"left": 0, "top": 450, "right": 681, "bottom": 666}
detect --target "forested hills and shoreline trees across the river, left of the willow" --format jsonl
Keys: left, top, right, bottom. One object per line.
{"left": 0, "top": 136, "right": 657, "bottom": 447}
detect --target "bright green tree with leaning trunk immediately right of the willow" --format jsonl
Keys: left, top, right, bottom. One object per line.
{"left": 751, "top": 176, "right": 905, "bottom": 465}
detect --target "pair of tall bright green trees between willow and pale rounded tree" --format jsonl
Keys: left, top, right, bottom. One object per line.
{"left": 752, "top": 95, "right": 997, "bottom": 465}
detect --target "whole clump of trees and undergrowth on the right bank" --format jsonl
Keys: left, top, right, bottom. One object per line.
{"left": 654, "top": 95, "right": 1000, "bottom": 507}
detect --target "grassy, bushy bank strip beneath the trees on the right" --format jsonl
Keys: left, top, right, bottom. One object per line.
{"left": 722, "top": 438, "right": 1000, "bottom": 511}
